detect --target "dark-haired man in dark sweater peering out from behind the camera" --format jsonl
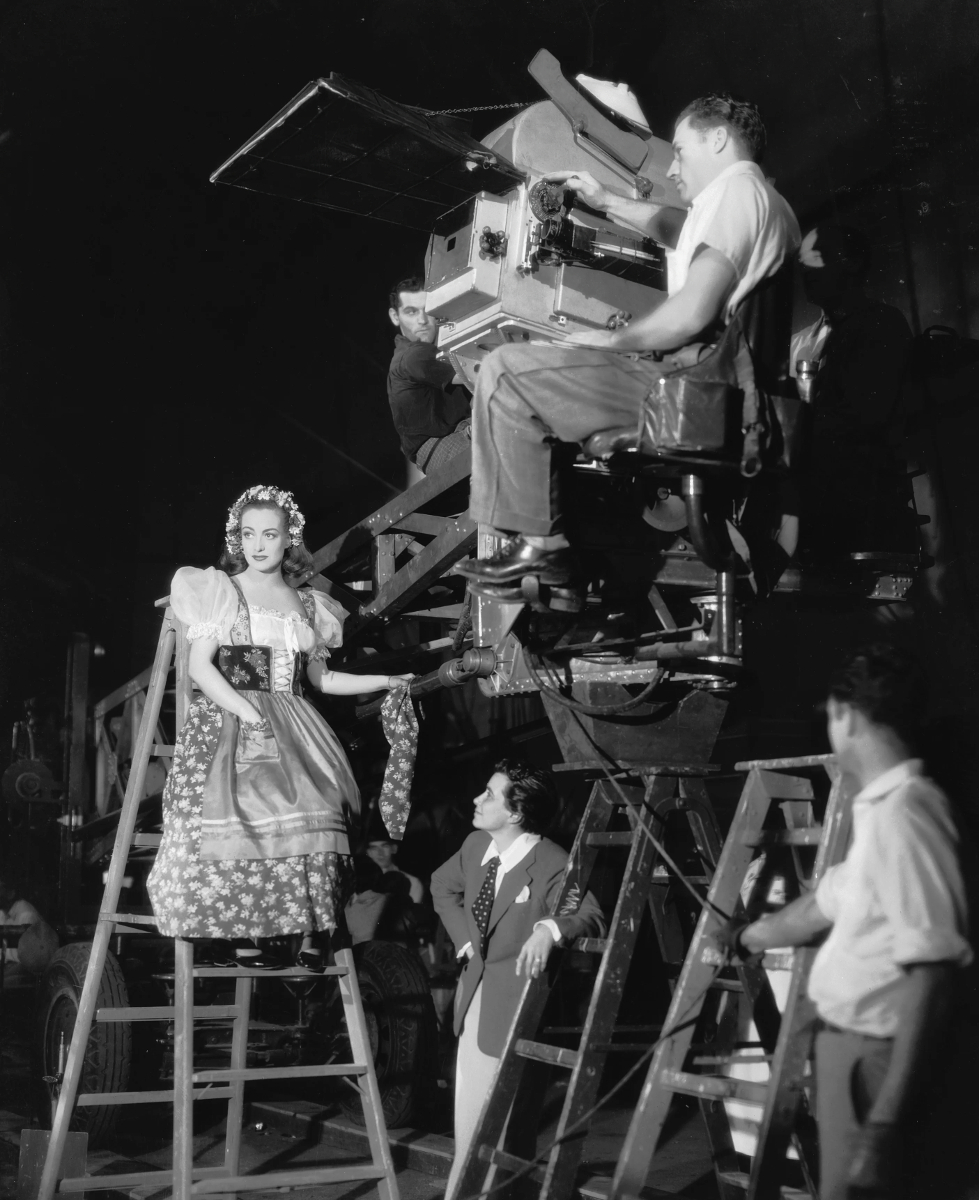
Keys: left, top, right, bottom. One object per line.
{"left": 388, "top": 276, "right": 470, "bottom": 472}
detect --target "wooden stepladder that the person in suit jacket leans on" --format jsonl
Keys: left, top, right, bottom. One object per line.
{"left": 446, "top": 763, "right": 721, "bottom": 1200}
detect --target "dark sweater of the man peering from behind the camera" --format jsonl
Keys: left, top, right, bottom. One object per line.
{"left": 388, "top": 334, "right": 469, "bottom": 462}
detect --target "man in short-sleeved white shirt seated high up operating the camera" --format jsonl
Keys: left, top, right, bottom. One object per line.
{"left": 458, "top": 96, "right": 799, "bottom": 586}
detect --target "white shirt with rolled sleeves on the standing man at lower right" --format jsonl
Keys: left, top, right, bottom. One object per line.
{"left": 809, "top": 758, "right": 972, "bottom": 1038}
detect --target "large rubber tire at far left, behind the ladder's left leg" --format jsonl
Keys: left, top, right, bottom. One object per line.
{"left": 34, "top": 942, "right": 132, "bottom": 1150}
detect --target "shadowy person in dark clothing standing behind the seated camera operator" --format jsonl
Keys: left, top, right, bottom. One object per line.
{"left": 792, "top": 223, "right": 913, "bottom": 554}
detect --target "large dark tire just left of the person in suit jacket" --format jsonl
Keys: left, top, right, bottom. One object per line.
{"left": 340, "top": 942, "right": 438, "bottom": 1129}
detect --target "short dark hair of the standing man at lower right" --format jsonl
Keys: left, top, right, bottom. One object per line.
{"left": 829, "top": 642, "right": 927, "bottom": 742}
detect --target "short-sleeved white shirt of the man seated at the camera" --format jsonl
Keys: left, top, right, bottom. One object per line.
{"left": 666, "top": 161, "right": 801, "bottom": 322}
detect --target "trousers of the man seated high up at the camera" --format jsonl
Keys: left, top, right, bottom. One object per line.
{"left": 469, "top": 346, "right": 663, "bottom": 536}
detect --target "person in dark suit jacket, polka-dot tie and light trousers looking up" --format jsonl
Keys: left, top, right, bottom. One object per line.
{"left": 432, "top": 760, "right": 605, "bottom": 1194}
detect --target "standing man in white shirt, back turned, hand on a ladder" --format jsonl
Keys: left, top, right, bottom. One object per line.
{"left": 719, "top": 646, "right": 973, "bottom": 1200}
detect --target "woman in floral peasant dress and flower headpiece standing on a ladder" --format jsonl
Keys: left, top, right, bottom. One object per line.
{"left": 148, "top": 486, "right": 410, "bottom": 970}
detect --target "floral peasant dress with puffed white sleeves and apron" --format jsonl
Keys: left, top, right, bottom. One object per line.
{"left": 148, "top": 568, "right": 360, "bottom": 938}
